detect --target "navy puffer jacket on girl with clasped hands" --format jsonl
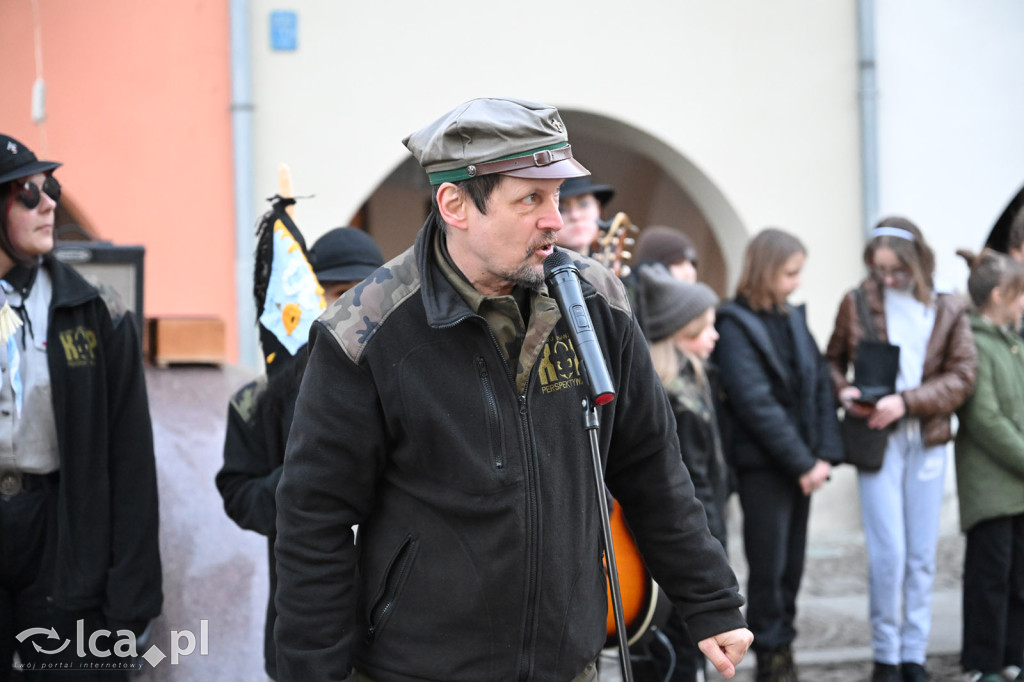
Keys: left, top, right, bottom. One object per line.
{"left": 714, "top": 301, "right": 843, "bottom": 479}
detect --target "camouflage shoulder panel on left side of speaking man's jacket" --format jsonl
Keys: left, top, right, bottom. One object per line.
{"left": 317, "top": 247, "right": 420, "bottom": 363}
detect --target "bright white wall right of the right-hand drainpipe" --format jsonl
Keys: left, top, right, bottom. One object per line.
{"left": 876, "top": 0, "right": 1024, "bottom": 291}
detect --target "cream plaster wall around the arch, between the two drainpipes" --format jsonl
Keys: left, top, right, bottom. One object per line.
{"left": 252, "top": 0, "right": 861, "bottom": 344}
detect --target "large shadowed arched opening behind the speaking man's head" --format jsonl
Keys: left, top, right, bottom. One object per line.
{"left": 353, "top": 110, "right": 748, "bottom": 296}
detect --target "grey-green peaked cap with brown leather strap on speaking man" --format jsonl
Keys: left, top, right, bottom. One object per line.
{"left": 402, "top": 97, "right": 590, "bottom": 184}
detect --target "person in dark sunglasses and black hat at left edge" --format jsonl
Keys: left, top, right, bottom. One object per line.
{"left": 0, "top": 134, "right": 163, "bottom": 682}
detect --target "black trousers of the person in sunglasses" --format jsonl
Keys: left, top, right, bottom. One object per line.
{"left": 0, "top": 480, "right": 132, "bottom": 682}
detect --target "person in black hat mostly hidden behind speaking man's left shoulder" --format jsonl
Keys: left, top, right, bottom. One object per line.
{"left": 216, "top": 220, "right": 384, "bottom": 679}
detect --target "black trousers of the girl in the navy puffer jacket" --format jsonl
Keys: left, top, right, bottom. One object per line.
{"left": 736, "top": 470, "right": 811, "bottom": 653}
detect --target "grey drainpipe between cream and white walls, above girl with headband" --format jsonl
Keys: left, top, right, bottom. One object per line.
{"left": 857, "top": 0, "right": 879, "bottom": 241}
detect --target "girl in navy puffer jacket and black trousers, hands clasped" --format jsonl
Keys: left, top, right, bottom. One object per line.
{"left": 714, "top": 228, "right": 843, "bottom": 682}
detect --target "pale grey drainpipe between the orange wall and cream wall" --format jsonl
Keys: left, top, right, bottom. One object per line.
{"left": 230, "top": 0, "right": 260, "bottom": 369}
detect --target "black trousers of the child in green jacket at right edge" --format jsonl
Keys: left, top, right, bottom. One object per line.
{"left": 961, "top": 514, "right": 1024, "bottom": 673}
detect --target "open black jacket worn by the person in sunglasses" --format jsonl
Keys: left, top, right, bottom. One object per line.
{"left": 43, "top": 256, "right": 163, "bottom": 634}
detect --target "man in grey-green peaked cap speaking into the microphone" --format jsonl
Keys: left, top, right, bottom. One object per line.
{"left": 274, "top": 98, "right": 752, "bottom": 682}
